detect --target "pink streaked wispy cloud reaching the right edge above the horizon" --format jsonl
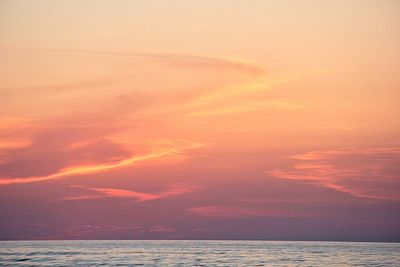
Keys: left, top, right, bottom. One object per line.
{"left": 268, "top": 147, "right": 400, "bottom": 200}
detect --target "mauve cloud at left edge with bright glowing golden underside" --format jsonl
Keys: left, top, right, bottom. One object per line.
{"left": 0, "top": 115, "right": 202, "bottom": 188}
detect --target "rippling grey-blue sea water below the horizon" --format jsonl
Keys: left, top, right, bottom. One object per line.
{"left": 0, "top": 241, "right": 400, "bottom": 266}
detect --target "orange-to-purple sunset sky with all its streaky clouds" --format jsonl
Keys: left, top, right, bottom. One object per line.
{"left": 0, "top": 0, "right": 400, "bottom": 242}
